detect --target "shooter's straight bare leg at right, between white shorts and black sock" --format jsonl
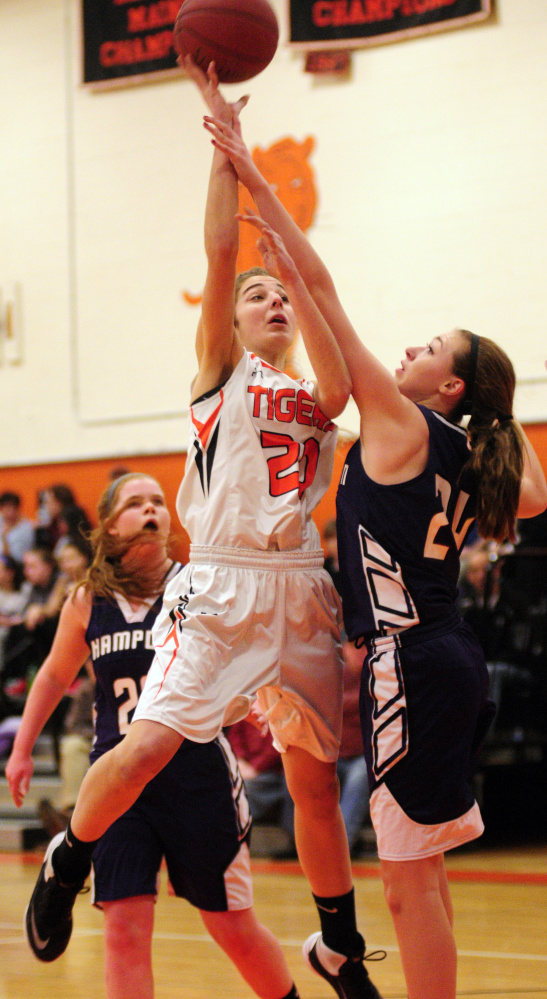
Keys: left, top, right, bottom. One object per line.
{"left": 282, "top": 746, "right": 352, "bottom": 898}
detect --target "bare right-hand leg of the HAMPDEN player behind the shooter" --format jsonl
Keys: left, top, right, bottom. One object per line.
{"left": 201, "top": 908, "right": 293, "bottom": 999}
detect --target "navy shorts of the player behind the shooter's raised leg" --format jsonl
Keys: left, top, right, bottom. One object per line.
{"left": 92, "top": 735, "right": 252, "bottom": 912}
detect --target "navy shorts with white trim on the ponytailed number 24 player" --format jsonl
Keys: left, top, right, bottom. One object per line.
{"left": 361, "top": 621, "right": 495, "bottom": 860}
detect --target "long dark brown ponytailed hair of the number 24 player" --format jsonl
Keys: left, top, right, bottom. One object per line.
{"left": 450, "top": 330, "right": 524, "bottom": 542}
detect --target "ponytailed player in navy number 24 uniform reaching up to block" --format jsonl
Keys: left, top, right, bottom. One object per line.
{"left": 199, "top": 103, "right": 547, "bottom": 999}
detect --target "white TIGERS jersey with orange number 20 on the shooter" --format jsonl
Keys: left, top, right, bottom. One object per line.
{"left": 177, "top": 351, "right": 337, "bottom": 551}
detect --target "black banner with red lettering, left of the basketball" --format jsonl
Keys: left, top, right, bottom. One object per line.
{"left": 82, "top": 0, "right": 182, "bottom": 86}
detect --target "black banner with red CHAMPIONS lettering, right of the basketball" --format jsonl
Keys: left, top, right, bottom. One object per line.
{"left": 288, "top": 0, "right": 492, "bottom": 50}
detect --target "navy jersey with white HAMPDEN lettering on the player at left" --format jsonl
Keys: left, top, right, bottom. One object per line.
{"left": 85, "top": 562, "right": 182, "bottom": 762}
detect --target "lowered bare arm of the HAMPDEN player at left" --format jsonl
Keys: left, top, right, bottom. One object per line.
{"left": 6, "top": 590, "right": 90, "bottom": 808}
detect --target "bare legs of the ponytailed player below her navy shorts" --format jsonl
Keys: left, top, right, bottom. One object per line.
{"left": 381, "top": 854, "right": 457, "bottom": 999}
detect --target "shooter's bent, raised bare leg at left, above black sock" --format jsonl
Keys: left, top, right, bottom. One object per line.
{"left": 71, "top": 720, "right": 182, "bottom": 843}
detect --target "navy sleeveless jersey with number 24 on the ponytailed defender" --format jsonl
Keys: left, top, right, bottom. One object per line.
{"left": 336, "top": 406, "right": 476, "bottom": 640}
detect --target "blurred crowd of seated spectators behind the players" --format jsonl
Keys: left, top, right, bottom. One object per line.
{"left": 0, "top": 469, "right": 547, "bottom": 859}
